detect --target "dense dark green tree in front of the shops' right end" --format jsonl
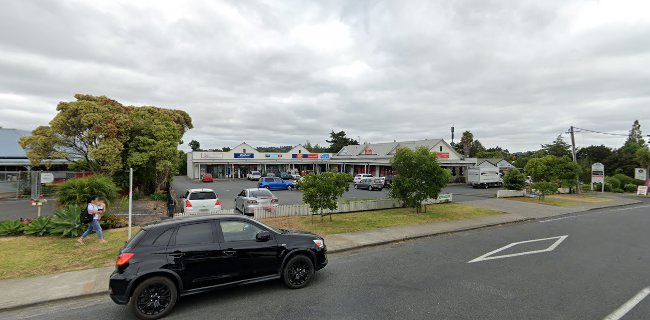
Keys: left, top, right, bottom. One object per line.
{"left": 388, "top": 147, "right": 451, "bottom": 213}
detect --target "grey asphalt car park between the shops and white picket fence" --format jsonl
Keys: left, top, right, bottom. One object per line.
{"left": 172, "top": 176, "right": 497, "bottom": 209}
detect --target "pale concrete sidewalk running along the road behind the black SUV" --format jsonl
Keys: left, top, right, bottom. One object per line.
{"left": 0, "top": 197, "right": 641, "bottom": 310}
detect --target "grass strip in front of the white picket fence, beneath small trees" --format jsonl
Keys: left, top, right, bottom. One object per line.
{"left": 263, "top": 203, "right": 500, "bottom": 236}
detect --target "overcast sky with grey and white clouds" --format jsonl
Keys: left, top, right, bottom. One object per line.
{"left": 0, "top": 0, "right": 650, "bottom": 151}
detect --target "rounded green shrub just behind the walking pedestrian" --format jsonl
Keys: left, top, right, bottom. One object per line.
{"left": 56, "top": 175, "right": 118, "bottom": 206}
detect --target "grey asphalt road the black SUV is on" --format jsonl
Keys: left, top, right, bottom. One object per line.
{"left": 5, "top": 199, "right": 650, "bottom": 320}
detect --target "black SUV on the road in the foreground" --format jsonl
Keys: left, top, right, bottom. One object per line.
{"left": 110, "top": 215, "right": 327, "bottom": 319}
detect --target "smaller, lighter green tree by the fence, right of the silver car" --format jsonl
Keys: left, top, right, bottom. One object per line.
{"left": 300, "top": 172, "right": 353, "bottom": 221}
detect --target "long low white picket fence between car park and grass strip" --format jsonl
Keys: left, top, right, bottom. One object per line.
{"left": 253, "top": 194, "right": 452, "bottom": 220}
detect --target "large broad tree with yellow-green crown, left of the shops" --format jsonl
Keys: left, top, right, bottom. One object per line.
{"left": 20, "top": 94, "right": 192, "bottom": 192}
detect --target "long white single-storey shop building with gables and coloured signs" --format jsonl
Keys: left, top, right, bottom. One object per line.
{"left": 187, "top": 139, "right": 475, "bottom": 182}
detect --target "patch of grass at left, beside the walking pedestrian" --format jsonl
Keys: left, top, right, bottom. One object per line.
{"left": 0, "top": 228, "right": 137, "bottom": 279}
